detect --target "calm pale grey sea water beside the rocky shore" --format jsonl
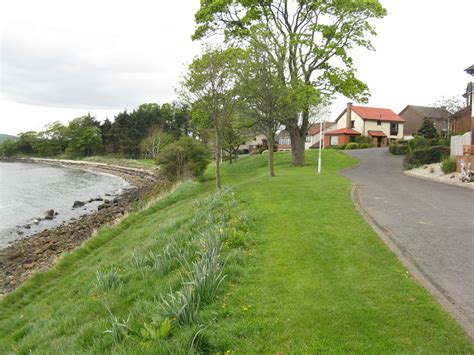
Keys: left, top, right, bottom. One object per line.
{"left": 0, "top": 162, "right": 131, "bottom": 248}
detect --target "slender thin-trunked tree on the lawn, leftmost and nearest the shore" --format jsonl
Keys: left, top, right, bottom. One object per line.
{"left": 181, "top": 46, "right": 241, "bottom": 190}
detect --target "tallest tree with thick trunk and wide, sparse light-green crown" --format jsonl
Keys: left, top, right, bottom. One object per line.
{"left": 193, "top": 0, "right": 386, "bottom": 165}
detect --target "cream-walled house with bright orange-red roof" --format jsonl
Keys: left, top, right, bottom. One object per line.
{"left": 324, "top": 102, "right": 405, "bottom": 147}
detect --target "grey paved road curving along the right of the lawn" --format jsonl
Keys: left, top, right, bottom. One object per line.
{"left": 343, "top": 148, "right": 474, "bottom": 336}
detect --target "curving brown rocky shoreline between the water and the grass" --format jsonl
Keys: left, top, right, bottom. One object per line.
{"left": 0, "top": 158, "right": 158, "bottom": 295}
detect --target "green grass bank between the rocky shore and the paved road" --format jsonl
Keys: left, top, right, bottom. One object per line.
{"left": 0, "top": 150, "right": 474, "bottom": 354}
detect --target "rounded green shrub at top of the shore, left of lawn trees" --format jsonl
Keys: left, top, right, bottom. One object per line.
{"left": 156, "top": 137, "right": 211, "bottom": 180}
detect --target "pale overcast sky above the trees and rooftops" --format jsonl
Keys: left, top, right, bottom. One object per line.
{"left": 0, "top": 0, "right": 474, "bottom": 134}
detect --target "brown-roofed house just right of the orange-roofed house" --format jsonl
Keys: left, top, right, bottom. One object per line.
{"left": 398, "top": 105, "right": 453, "bottom": 136}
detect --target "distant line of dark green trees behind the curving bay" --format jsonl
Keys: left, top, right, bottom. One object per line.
{"left": 0, "top": 102, "right": 196, "bottom": 158}
